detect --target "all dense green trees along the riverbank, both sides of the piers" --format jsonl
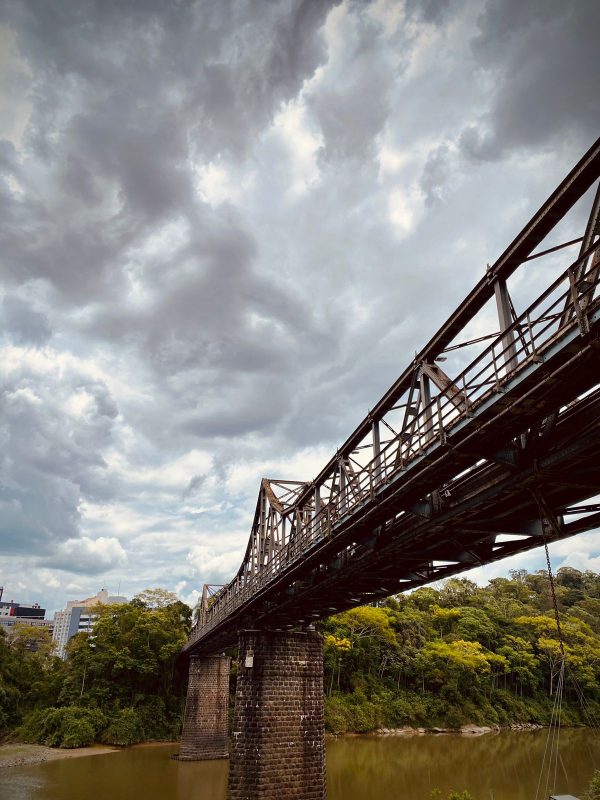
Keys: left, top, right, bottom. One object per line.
{"left": 0, "top": 567, "right": 600, "bottom": 747}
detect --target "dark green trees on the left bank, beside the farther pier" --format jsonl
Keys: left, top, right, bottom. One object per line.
{"left": 0, "top": 589, "right": 191, "bottom": 747}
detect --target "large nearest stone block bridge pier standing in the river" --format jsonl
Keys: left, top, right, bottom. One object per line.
{"left": 228, "top": 631, "right": 326, "bottom": 800}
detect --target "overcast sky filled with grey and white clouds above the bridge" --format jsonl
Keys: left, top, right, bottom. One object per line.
{"left": 0, "top": 0, "right": 600, "bottom": 610}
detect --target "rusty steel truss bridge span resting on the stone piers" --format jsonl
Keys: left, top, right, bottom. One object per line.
{"left": 185, "top": 139, "right": 600, "bottom": 653}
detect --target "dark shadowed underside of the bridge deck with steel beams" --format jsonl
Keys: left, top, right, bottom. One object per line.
{"left": 192, "top": 376, "right": 600, "bottom": 650}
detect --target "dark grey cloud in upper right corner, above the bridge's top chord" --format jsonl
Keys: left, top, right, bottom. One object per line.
{"left": 461, "top": 0, "right": 600, "bottom": 160}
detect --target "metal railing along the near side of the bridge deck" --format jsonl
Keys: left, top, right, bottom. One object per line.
{"left": 189, "top": 236, "right": 600, "bottom": 644}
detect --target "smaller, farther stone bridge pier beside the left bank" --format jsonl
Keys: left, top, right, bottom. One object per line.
{"left": 176, "top": 656, "right": 231, "bottom": 761}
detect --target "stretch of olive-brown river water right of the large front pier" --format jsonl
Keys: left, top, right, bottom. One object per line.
{"left": 327, "top": 730, "right": 600, "bottom": 800}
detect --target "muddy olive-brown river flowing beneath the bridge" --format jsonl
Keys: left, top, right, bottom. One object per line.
{"left": 0, "top": 730, "right": 600, "bottom": 800}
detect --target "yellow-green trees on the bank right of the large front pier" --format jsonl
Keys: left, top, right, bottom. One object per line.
{"left": 322, "top": 568, "right": 600, "bottom": 733}
